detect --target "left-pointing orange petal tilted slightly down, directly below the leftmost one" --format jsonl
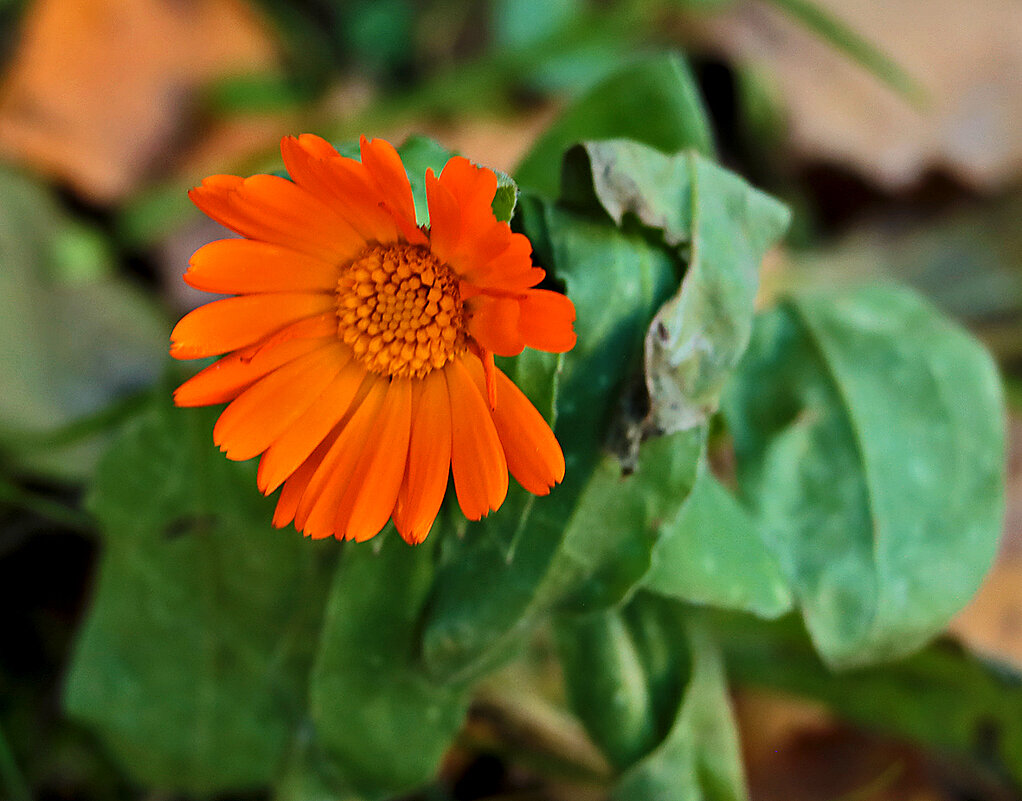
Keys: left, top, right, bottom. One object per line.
{"left": 174, "top": 337, "right": 333, "bottom": 407}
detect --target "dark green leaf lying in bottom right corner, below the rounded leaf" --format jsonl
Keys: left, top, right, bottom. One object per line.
{"left": 714, "top": 615, "right": 1022, "bottom": 790}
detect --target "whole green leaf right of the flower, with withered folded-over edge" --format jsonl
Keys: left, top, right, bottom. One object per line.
{"left": 425, "top": 135, "right": 787, "bottom": 676}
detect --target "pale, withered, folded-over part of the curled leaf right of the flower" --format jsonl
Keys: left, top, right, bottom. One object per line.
{"left": 564, "top": 140, "right": 789, "bottom": 433}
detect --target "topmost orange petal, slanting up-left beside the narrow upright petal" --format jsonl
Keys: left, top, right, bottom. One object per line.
{"left": 280, "top": 134, "right": 399, "bottom": 244}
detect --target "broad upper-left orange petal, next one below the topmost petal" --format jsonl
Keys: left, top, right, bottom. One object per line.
{"left": 188, "top": 175, "right": 366, "bottom": 262}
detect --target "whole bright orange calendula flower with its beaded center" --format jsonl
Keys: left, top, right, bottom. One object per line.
{"left": 171, "top": 134, "right": 575, "bottom": 544}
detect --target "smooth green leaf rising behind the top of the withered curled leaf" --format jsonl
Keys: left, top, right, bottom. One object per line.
{"left": 515, "top": 54, "right": 713, "bottom": 197}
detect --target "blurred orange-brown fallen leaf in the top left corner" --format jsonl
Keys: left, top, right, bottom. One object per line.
{"left": 0, "top": 0, "right": 277, "bottom": 202}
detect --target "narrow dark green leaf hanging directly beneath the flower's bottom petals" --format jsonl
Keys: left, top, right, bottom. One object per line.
{"left": 310, "top": 529, "right": 468, "bottom": 799}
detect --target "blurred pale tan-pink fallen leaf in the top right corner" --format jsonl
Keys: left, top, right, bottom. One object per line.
{"left": 697, "top": 0, "right": 1022, "bottom": 189}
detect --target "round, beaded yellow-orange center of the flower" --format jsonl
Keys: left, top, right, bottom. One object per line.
{"left": 337, "top": 245, "right": 466, "bottom": 378}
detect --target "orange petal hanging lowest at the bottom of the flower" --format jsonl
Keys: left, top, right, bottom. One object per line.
{"left": 393, "top": 370, "right": 451, "bottom": 545}
